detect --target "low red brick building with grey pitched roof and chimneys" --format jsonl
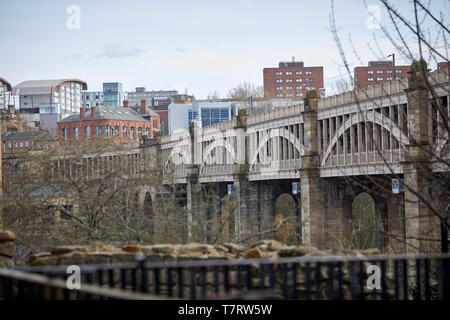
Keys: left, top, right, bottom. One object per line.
{"left": 58, "top": 100, "right": 160, "bottom": 145}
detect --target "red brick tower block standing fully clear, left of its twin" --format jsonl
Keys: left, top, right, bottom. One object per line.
{"left": 263, "top": 58, "right": 323, "bottom": 100}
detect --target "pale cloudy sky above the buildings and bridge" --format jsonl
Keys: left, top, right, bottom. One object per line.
{"left": 0, "top": 0, "right": 450, "bottom": 97}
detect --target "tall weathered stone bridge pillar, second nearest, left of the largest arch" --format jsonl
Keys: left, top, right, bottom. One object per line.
{"left": 300, "top": 91, "right": 325, "bottom": 248}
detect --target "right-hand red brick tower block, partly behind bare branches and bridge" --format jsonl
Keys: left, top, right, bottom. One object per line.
{"left": 354, "top": 61, "right": 411, "bottom": 89}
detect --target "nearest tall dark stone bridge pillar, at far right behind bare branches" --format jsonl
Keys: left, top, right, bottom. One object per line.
{"left": 403, "top": 60, "right": 443, "bottom": 253}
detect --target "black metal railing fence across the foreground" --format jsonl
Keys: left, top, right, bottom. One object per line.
{"left": 5, "top": 255, "right": 450, "bottom": 300}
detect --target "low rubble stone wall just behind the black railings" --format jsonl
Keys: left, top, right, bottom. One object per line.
{"left": 28, "top": 240, "right": 380, "bottom": 266}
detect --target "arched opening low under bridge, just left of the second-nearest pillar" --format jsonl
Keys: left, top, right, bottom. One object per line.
{"left": 275, "top": 192, "right": 301, "bottom": 244}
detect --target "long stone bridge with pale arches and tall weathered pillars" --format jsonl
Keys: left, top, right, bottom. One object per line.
{"left": 154, "top": 64, "right": 450, "bottom": 252}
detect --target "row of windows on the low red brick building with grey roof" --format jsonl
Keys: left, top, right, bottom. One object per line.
{"left": 62, "top": 125, "right": 150, "bottom": 140}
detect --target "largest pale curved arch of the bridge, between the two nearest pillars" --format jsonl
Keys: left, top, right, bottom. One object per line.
{"left": 320, "top": 110, "right": 409, "bottom": 167}
